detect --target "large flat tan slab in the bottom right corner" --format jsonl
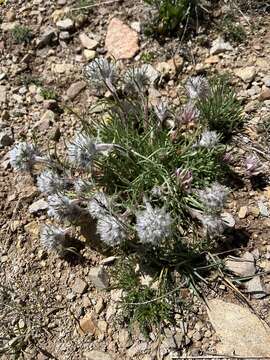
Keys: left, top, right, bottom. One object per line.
{"left": 208, "top": 299, "right": 270, "bottom": 357}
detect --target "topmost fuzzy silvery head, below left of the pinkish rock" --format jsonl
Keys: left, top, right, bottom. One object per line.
{"left": 85, "top": 58, "right": 118, "bottom": 93}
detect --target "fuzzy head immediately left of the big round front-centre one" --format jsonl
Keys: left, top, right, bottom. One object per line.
{"left": 97, "top": 215, "right": 126, "bottom": 246}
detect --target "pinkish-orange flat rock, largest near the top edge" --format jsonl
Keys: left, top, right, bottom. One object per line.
{"left": 105, "top": 18, "right": 139, "bottom": 60}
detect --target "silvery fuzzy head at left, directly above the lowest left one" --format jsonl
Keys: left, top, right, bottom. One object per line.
{"left": 48, "top": 193, "right": 83, "bottom": 222}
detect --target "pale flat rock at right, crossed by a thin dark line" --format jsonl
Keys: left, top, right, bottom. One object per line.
{"left": 225, "top": 252, "right": 256, "bottom": 276}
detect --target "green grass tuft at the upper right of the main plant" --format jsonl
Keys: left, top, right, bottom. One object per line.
{"left": 197, "top": 75, "right": 243, "bottom": 139}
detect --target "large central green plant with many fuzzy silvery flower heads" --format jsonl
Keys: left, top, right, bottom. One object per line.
{"left": 10, "top": 58, "right": 245, "bottom": 331}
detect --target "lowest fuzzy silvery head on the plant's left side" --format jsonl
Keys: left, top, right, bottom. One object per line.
{"left": 40, "top": 225, "right": 66, "bottom": 253}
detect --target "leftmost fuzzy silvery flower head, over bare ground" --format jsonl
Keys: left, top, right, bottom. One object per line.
{"left": 9, "top": 142, "right": 37, "bottom": 171}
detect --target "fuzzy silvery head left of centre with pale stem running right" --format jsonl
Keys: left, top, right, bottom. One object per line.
{"left": 68, "top": 134, "right": 97, "bottom": 168}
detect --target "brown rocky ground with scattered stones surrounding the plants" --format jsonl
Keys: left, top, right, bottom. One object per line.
{"left": 0, "top": 0, "right": 270, "bottom": 360}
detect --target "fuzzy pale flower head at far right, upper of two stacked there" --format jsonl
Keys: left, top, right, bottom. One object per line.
{"left": 198, "top": 182, "right": 229, "bottom": 213}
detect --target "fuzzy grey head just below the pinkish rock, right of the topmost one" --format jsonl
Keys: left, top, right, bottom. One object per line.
{"left": 124, "top": 68, "right": 150, "bottom": 94}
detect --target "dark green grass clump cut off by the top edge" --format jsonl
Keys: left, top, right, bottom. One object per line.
{"left": 144, "top": 0, "right": 209, "bottom": 35}
